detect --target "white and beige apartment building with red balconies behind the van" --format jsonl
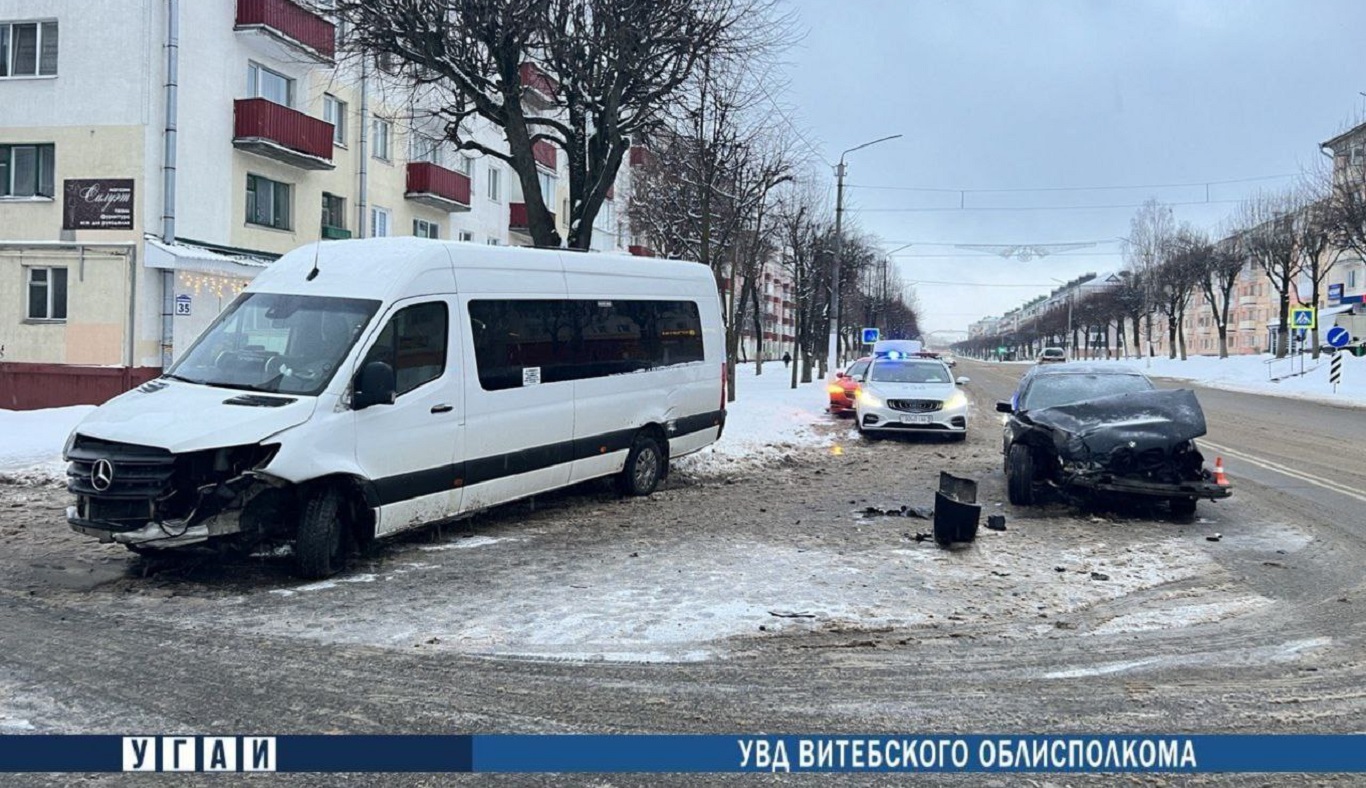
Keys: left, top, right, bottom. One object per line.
{"left": 0, "top": 0, "right": 633, "bottom": 408}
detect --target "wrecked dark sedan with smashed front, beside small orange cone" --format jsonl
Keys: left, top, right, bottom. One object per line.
{"left": 996, "top": 363, "right": 1232, "bottom": 518}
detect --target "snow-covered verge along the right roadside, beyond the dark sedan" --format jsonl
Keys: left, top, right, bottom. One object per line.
{"left": 988, "top": 354, "right": 1366, "bottom": 406}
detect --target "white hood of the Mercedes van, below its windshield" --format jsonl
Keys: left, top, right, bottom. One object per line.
{"left": 76, "top": 378, "right": 317, "bottom": 453}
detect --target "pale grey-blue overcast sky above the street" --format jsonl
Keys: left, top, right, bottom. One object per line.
{"left": 784, "top": 0, "right": 1366, "bottom": 330}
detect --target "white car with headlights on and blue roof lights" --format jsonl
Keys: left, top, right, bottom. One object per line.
{"left": 854, "top": 354, "right": 968, "bottom": 441}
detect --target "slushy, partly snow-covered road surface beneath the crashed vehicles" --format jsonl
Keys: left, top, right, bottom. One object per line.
{"left": 0, "top": 362, "right": 1366, "bottom": 785}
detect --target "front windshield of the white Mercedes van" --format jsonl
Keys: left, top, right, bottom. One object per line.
{"left": 167, "top": 292, "right": 380, "bottom": 395}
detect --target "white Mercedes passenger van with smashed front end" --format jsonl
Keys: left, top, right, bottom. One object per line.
{"left": 64, "top": 238, "right": 725, "bottom": 578}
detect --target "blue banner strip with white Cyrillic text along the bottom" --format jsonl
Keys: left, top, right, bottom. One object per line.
{"left": 0, "top": 733, "right": 1366, "bottom": 773}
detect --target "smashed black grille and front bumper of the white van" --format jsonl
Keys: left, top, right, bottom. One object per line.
{"left": 67, "top": 436, "right": 288, "bottom": 549}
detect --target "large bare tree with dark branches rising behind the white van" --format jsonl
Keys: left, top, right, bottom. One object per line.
{"left": 328, "top": 0, "right": 776, "bottom": 249}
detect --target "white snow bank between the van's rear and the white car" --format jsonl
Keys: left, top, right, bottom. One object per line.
{"left": 673, "top": 362, "right": 831, "bottom": 475}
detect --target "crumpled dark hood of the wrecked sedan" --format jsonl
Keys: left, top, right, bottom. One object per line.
{"left": 1025, "top": 389, "right": 1205, "bottom": 462}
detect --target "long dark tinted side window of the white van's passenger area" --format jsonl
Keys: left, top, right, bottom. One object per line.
{"left": 470, "top": 299, "right": 703, "bottom": 391}
